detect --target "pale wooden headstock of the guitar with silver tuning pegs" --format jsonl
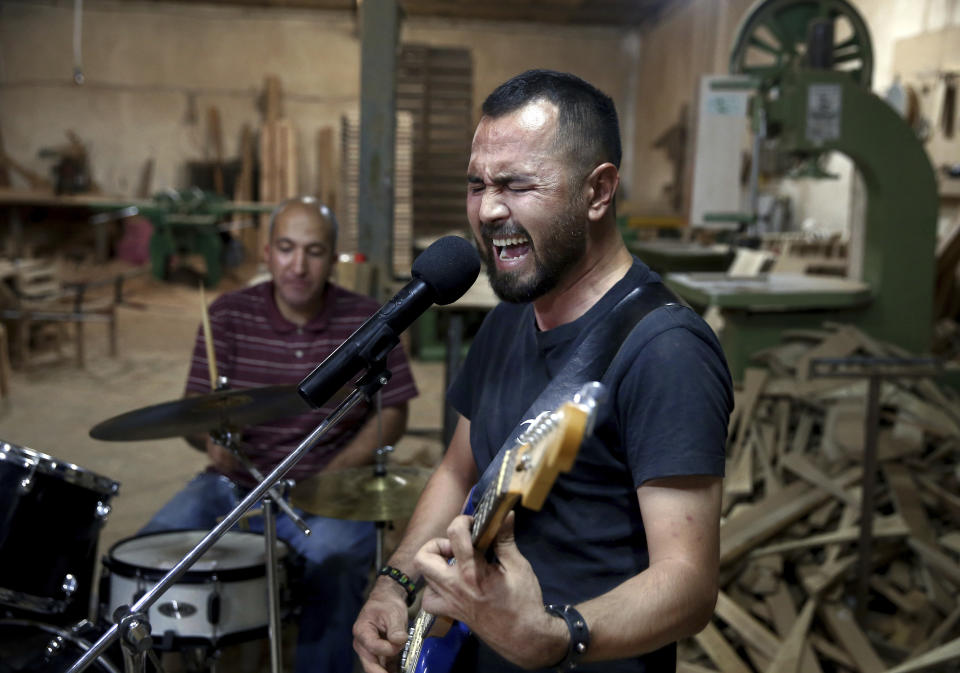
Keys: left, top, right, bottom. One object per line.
{"left": 498, "top": 381, "right": 604, "bottom": 510}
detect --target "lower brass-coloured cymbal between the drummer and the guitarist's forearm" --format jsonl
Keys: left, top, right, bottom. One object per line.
{"left": 290, "top": 466, "right": 432, "bottom": 521}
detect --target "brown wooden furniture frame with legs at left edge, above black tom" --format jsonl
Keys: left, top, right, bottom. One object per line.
{"left": 0, "top": 260, "right": 117, "bottom": 369}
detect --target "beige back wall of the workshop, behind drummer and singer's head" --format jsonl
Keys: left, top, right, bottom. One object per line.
{"left": 0, "top": 0, "right": 638, "bottom": 205}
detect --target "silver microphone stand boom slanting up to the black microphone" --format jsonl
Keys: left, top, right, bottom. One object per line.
{"left": 66, "top": 364, "right": 391, "bottom": 673}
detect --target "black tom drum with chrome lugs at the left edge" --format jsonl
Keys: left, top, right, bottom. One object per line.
{"left": 0, "top": 441, "right": 120, "bottom": 623}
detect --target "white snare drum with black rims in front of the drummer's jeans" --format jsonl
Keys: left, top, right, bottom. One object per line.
{"left": 100, "top": 531, "right": 287, "bottom": 649}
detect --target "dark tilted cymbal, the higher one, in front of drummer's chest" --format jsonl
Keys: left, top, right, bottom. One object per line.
{"left": 90, "top": 385, "right": 310, "bottom": 442}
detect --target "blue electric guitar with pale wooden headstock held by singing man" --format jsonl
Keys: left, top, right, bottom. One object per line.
{"left": 400, "top": 382, "right": 603, "bottom": 673}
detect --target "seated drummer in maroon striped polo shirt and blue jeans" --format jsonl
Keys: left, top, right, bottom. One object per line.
{"left": 141, "top": 197, "right": 417, "bottom": 673}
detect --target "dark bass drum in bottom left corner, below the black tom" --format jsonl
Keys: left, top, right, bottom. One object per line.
{"left": 0, "top": 619, "right": 120, "bottom": 673}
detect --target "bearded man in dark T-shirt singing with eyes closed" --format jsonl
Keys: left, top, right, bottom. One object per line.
{"left": 354, "top": 70, "right": 733, "bottom": 673}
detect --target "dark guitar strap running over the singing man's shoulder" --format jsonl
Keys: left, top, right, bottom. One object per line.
{"left": 473, "top": 282, "right": 682, "bottom": 505}
